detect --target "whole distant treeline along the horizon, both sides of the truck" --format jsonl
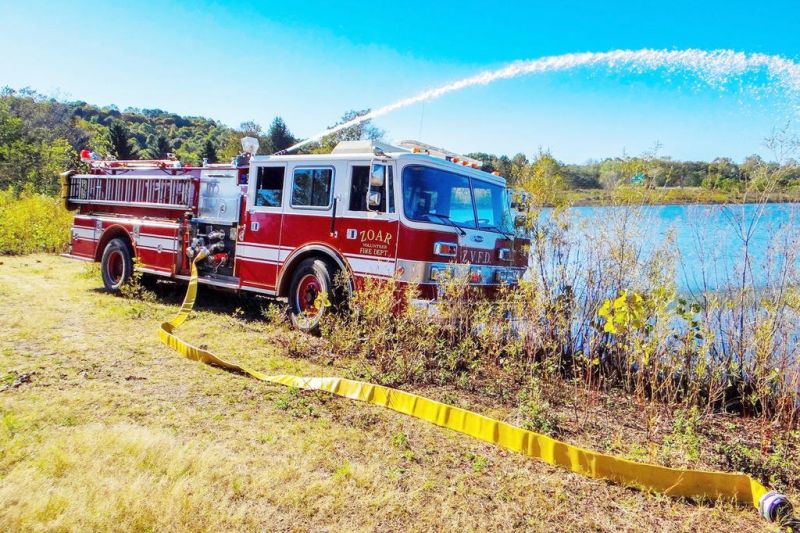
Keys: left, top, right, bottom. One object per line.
{"left": 0, "top": 88, "right": 800, "bottom": 193}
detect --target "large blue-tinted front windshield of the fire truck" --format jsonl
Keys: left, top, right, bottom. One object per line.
{"left": 403, "top": 165, "right": 511, "bottom": 233}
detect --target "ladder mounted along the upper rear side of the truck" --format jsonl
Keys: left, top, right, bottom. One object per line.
{"left": 67, "top": 174, "right": 196, "bottom": 209}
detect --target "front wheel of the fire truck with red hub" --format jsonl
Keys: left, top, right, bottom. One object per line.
{"left": 289, "top": 257, "right": 336, "bottom": 333}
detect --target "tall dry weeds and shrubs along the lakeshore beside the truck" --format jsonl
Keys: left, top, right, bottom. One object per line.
{"left": 323, "top": 196, "right": 800, "bottom": 428}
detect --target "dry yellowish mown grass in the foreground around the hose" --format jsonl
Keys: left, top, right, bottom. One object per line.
{"left": 0, "top": 256, "right": 796, "bottom": 531}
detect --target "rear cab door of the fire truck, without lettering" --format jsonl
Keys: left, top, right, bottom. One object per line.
{"left": 236, "top": 163, "right": 286, "bottom": 292}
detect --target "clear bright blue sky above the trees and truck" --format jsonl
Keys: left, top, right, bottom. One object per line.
{"left": 0, "top": 0, "right": 800, "bottom": 162}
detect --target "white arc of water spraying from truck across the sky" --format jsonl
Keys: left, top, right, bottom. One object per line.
{"left": 280, "top": 49, "right": 800, "bottom": 153}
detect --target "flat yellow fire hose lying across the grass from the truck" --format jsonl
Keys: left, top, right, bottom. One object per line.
{"left": 159, "top": 254, "right": 792, "bottom": 522}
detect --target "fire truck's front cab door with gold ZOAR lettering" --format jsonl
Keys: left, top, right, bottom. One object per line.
{"left": 338, "top": 160, "right": 399, "bottom": 277}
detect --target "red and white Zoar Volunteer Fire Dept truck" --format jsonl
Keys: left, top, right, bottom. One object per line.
{"left": 62, "top": 138, "right": 527, "bottom": 330}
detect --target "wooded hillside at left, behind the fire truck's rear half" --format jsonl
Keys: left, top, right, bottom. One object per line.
{"left": 0, "top": 88, "right": 295, "bottom": 193}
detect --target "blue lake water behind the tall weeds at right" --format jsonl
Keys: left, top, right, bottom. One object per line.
{"left": 543, "top": 204, "right": 800, "bottom": 291}
